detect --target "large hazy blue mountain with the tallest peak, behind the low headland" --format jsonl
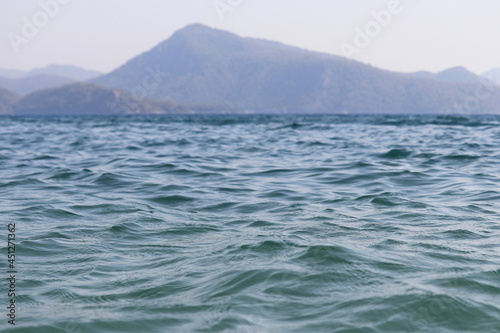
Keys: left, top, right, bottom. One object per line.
{"left": 92, "top": 24, "right": 500, "bottom": 113}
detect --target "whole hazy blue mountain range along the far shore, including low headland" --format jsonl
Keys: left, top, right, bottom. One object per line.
{"left": 0, "top": 24, "right": 500, "bottom": 115}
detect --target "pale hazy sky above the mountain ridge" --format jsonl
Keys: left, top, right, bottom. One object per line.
{"left": 0, "top": 0, "right": 500, "bottom": 74}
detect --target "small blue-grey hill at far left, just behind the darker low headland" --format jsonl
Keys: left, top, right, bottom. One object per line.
{"left": 0, "top": 74, "right": 74, "bottom": 95}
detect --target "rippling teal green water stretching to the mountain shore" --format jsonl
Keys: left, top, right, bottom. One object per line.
{"left": 0, "top": 116, "right": 500, "bottom": 333}
